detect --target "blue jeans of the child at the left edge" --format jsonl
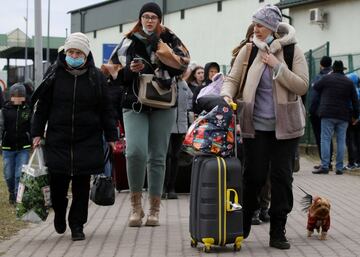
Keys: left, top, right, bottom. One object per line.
{"left": 3, "top": 149, "right": 30, "bottom": 197}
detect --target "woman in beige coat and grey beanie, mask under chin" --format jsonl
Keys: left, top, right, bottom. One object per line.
{"left": 221, "top": 5, "right": 308, "bottom": 249}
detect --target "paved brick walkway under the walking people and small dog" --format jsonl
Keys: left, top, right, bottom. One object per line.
{"left": 0, "top": 155, "right": 360, "bottom": 257}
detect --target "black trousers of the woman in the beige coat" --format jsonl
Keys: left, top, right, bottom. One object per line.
{"left": 243, "top": 131, "right": 299, "bottom": 222}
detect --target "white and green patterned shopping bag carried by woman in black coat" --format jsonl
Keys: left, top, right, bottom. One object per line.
{"left": 16, "top": 147, "right": 51, "bottom": 223}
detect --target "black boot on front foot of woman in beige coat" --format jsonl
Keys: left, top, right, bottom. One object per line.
{"left": 269, "top": 218, "right": 290, "bottom": 250}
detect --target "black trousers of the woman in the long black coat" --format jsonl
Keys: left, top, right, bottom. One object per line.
{"left": 49, "top": 171, "right": 90, "bottom": 228}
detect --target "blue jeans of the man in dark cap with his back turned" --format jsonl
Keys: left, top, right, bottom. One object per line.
{"left": 320, "top": 118, "right": 349, "bottom": 170}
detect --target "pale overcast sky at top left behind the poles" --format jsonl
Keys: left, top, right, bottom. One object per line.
{"left": 0, "top": 0, "right": 105, "bottom": 37}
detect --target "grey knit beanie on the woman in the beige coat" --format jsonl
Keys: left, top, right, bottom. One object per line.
{"left": 252, "top": 4, "right": 282, "bottom": 32}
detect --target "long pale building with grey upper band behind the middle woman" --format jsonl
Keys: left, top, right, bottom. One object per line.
{"left": 70, "top": 0, "right": 278, "bottom": 69}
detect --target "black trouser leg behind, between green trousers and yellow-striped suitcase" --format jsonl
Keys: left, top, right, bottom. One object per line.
{"left": 164, "top": 134, "right": 184, "bottom": 192}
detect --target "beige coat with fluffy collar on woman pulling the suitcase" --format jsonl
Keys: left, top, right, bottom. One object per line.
{"left": 221, "top": 23, "right": 309, "bottom": 139}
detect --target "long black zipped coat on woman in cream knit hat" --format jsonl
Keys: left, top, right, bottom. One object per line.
{"left": 31, "top": 53, "right": 117, "bottom": 175}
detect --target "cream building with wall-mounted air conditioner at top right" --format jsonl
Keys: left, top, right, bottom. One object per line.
{"left": 279, "top": 0, "right": 360, "bottom": 55}
